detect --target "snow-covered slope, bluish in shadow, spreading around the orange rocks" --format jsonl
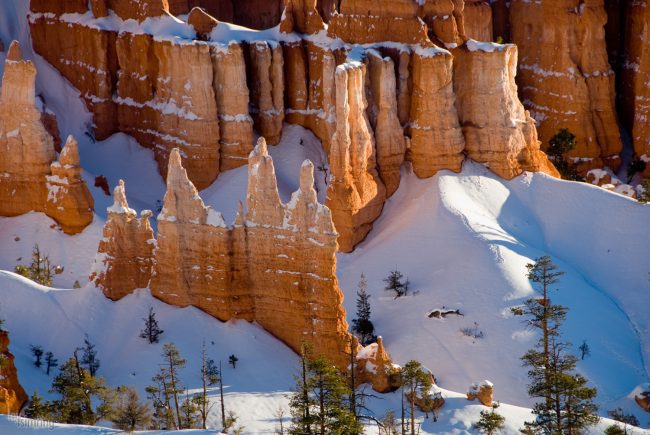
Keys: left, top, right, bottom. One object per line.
{"left": 0, "top": 0, "right": 650, "bottom": 434}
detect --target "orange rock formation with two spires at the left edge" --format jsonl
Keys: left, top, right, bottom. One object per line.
{"left": 0, "top": 41, "right": 93, "bottom": 234}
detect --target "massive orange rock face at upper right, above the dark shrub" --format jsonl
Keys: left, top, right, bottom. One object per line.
{"left": 510, "top": 0, "right": 622, "bottom": 172}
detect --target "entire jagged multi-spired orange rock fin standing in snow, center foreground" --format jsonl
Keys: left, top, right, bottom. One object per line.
{"left": 98, "top": 143, "right": 350, "bottom": 367}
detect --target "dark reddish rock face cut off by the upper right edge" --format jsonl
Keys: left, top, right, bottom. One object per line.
{"left": 621, "top": 0, "right": 650, "bottom": 177}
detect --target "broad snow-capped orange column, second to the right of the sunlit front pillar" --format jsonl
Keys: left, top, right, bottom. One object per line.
{"left": 410, "top": 48, "right": 465, "bottom": 178}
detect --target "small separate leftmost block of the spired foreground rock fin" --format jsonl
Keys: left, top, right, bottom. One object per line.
{"left": 90, "top": 180, "right": 155, "bottom": 301}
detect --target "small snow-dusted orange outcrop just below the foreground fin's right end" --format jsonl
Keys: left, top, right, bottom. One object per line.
{"left": 355, "top": 337, "right": 401, "bottom": 393}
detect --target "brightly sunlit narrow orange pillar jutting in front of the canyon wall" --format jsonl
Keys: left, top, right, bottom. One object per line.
{"left": 327, "top": 64, "right": 386, "bottom": 252}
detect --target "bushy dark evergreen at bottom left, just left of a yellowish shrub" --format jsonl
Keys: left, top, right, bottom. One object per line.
{"left": 50, "top": 351, "right": 113, "bottom": 425}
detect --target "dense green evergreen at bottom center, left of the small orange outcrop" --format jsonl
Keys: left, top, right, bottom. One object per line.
{"left": 289, "top": 354, "right": 363, "bottom": 435}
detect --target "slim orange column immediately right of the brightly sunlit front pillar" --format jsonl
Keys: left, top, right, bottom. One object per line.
{"left": 368, "top": 50, "right": 406, "bottom": 197}
